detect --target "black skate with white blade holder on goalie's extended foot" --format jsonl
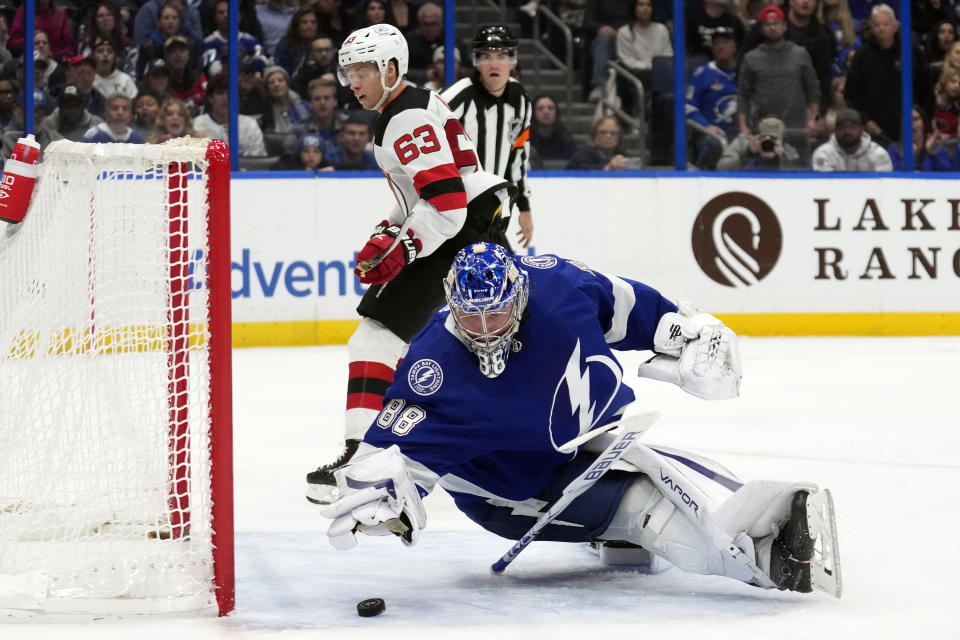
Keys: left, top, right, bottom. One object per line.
{"left": 769, "top": 489, "right": 843, "bottom": 598}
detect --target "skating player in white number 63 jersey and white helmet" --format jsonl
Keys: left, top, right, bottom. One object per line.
{"left": 307, "top": 24, "right": 516, "bottom": 504}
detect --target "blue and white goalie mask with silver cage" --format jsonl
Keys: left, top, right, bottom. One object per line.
{"left": 443, "top": 242, "right": 529, "bottom": 378}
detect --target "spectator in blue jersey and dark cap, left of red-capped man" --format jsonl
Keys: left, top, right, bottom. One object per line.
{"left": 686, "top": 28, "right": 738, "bottom": 171}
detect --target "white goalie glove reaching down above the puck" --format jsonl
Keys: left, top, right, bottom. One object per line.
{"left": 320, "top": 445, "right": 427, "bottom": 550}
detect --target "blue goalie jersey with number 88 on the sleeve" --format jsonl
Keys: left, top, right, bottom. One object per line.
{"left": 364, "top": 255, "right": 677, "bottom": 519}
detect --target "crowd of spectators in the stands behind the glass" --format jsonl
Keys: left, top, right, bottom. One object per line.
{"left": 0, "top": 0, "right": 960, "bottom": 171}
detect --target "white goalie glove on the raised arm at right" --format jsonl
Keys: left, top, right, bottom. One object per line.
{"left": 637, "top": 300, "right": 743, "bottom": 400}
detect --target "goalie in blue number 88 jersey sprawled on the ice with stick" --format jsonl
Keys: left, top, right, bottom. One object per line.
{"left": 321, "top": 243, "right": 842, "bottom": 597}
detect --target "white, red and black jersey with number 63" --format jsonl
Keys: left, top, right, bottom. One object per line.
{"left": 373, "top": 87, "right": 496, "bottom": 256}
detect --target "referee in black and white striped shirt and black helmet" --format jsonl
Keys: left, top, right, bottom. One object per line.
{"left": 440, "top": 24, "right": 533, "bottom": 249}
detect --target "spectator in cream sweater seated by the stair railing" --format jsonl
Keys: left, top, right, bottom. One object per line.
{"left": 617, "top": 0, "right": 673, "bottom": 102}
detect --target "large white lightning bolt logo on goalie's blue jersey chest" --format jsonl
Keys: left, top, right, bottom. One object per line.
{"left": 549, "top": 340, "right": 623, "bottom": 451}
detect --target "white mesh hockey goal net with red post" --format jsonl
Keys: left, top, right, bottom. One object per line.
{"left": 0, "top": 139, "right": 234, "bottom": 615}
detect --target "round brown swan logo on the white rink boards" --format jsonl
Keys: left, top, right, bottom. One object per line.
{"left": 693, "top": 191, "right": 783, "bottom": 287}
